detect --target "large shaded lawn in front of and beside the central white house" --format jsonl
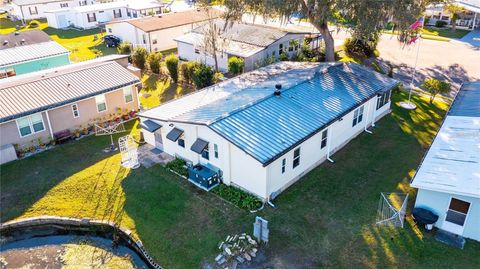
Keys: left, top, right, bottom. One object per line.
{"left": 0, "top": 93, "right": 480, "bottom": 268}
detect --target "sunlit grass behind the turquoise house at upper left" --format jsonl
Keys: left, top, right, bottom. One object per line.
{"left": 0, "top": 16, "right": 117, "bottom": 62}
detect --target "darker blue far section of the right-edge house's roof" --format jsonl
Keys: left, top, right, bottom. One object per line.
{"left": 448, "top": 81, "right": 480, "bottom": 117}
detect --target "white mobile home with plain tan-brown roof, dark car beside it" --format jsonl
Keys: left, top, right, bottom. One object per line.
{"left": 106, "top": 9, "right": 222, "bottom": 52}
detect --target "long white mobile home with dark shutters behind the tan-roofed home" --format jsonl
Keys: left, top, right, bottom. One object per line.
{"left": 45, "top": 0, "right": 164, "bottom": 29}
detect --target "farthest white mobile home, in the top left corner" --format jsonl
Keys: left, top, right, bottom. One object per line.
{"left": 10, "top": 0, "right": 95, "bottom": 20}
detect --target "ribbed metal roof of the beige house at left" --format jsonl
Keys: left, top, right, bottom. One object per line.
{"left": 0, "top": 60, "right": 140, "bottom": 122}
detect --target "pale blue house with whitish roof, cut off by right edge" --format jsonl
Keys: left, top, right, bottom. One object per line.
{"left": 410, "top": 81, "right": 480, "bottom": 241}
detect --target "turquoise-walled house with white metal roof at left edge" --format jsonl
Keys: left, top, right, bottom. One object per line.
{"left": 0, "top": 30, "right": 70, "bottom": 79}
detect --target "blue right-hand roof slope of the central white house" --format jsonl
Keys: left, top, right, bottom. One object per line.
{"left": 209, "top": 64, "right": 397, "bottom": 165}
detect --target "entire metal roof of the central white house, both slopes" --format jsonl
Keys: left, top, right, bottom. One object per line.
{"left": 140, "top": 62, "right": 397, "bottom": 165}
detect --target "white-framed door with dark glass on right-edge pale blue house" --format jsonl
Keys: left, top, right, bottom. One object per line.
{"left": 442, "top": 198, "right": 470, "bottom": 235}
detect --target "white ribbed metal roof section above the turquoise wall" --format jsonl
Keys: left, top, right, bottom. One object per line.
{"left": 0, "top": 41, "right": 70, "bottom": 67}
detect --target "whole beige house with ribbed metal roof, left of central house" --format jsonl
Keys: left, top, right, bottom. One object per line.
{"left": 0, "top": 55, "right": 141, "bottom": 163}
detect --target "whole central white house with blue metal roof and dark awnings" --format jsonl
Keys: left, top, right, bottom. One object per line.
{"left": 139, "top": 62, "right": 397, "bottom": 200}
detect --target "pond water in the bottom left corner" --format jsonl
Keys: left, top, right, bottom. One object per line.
{"left": 0, "top": 235, "right": 148, "bottom": 268}
